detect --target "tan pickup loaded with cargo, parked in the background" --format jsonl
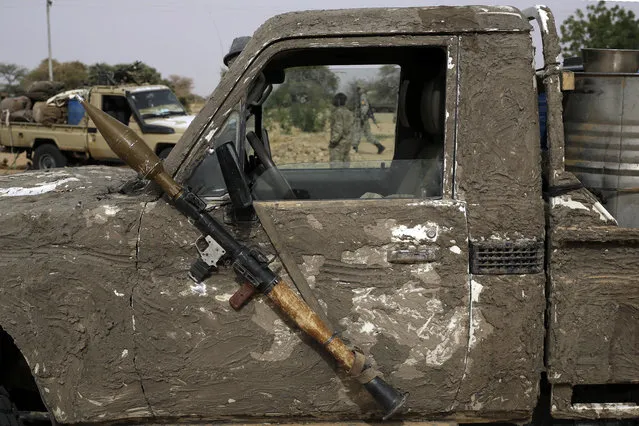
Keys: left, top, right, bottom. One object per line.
{"left": 0, "top": 86, "right": 194, "bottom": 169}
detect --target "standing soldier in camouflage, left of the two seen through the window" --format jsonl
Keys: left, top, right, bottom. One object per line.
{"left": 328, "top": 93, "right": 353, "bottom": 167}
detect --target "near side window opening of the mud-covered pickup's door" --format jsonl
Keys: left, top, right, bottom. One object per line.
{"left": 251, "top": 48, "right": 447, "bottom": 200}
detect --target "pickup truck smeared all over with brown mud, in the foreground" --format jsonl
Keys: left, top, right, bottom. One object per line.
{"left": 0, "top": 6, "right": 639, "bottom": 426}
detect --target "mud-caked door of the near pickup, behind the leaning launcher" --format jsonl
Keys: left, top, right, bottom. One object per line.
{"left": 132, "top": 37, "right": 478, "bottom": 418}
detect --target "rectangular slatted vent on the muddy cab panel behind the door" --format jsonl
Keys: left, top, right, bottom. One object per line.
{"left": 470, "top": 240, "right": 544, "bottom": 275}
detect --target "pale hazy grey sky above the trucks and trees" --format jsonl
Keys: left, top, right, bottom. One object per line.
{"left": 0, "top": 0, "right": 639, "bottom": 96}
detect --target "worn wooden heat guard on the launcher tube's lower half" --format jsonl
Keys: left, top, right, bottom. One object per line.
{"left": 268, "top": 280, "right": 355, "bottom": 371}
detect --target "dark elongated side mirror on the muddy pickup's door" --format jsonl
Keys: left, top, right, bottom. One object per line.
{"left": 215, "top": 142, "right": 253, "bottom": 210}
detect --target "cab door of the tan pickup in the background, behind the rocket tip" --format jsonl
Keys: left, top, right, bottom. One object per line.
{"left": 87, "top": 93, "right": 131, "bottom": 160}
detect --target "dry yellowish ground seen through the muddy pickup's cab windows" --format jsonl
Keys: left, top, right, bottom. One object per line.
{"left": 269, "top": 113, "right": 395, "bottom": 165}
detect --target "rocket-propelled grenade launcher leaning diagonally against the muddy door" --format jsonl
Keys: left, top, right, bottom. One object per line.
{"left": 80, "top": 98, "right": 407, "bottom": 419}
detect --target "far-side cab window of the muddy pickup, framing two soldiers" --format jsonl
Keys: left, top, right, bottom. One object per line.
{"left": 263, "top": 64, "right": 400, "bottom": 165}
